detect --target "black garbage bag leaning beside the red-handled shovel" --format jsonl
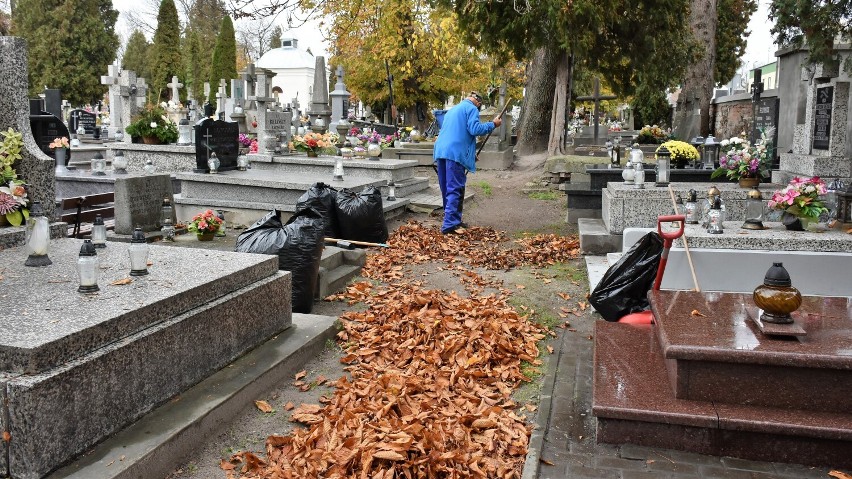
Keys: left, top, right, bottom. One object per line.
{"left": 589, "top": 232, "right": 663, "bottom": 321}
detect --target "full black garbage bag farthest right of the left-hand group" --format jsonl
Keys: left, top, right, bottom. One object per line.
{"left": 337, "top": 187, "right": 388, "bottom": 243}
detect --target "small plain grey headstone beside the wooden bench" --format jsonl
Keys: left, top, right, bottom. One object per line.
{"left": 114, "top": 173, "right": 174, "bottom": 235}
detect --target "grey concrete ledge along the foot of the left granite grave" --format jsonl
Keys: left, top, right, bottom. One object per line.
{"left": 48, "top": 313, "right": 337, "bottom": 479}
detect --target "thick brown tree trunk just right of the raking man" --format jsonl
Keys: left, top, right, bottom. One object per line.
{"left": 518, "top": 47, "right": 559, "bottom": 155}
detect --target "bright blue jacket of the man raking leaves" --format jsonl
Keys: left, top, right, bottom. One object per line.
{"left": 432, "top": 99, "right": 494, "bottom": 171}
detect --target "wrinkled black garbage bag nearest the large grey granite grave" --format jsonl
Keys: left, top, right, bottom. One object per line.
{"left": 236, "top": 208, "right": 325, "bottom": 313}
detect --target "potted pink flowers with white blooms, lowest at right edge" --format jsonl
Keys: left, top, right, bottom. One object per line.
{"left": 768, "top": 176, "right": 828, "bottom": 231}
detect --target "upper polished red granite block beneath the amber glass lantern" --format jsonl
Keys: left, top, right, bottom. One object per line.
{"left": 649, "top": 291, "right": 852, "bottom": 413}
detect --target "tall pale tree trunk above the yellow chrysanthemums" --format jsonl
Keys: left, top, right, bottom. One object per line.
{"left": 678, "top": 0, "right": 719, "bottom": 141}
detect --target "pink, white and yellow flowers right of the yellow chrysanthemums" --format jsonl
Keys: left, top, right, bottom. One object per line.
{"left": 710, "top": 135, "right": 770, "bottom": 188}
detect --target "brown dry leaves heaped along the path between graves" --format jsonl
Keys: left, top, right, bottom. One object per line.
{"left": 222, "top": 223, "right": 576, "bottom": 479}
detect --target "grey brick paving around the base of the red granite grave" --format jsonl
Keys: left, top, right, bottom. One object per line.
{"left": 536, "top": 314, "right": 836, "bottom": 479}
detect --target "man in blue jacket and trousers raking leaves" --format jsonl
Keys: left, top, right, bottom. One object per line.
{"left": 433, "top": 91, "right": 503, "bottom": 234}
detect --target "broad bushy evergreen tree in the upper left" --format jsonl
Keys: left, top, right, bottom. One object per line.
{"left": 12, "top": 0, "right": 118, "bottom": 105}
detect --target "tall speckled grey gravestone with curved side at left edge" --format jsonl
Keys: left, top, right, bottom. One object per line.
{"left": 0, "top": 36, "right": 56, "bottom": 221}
